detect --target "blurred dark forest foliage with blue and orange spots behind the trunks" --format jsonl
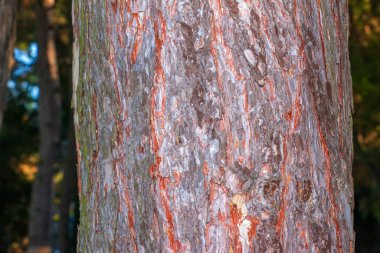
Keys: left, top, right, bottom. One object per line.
{"left": 0, "top": 0, "right": 380, "bottom": 253}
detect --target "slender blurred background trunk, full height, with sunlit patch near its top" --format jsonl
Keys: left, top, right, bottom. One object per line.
{"left": 29, "top": 0, "right": 61, "bottom": 253}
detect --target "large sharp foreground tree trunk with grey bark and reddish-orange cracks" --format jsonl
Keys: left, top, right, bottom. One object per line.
{"left": 73, "top": 0, "right": 354, "bottom": 252}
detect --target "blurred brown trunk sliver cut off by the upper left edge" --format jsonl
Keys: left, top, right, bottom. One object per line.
{"left": 0, "top": 0, "right": 18, "bottom": 129}
